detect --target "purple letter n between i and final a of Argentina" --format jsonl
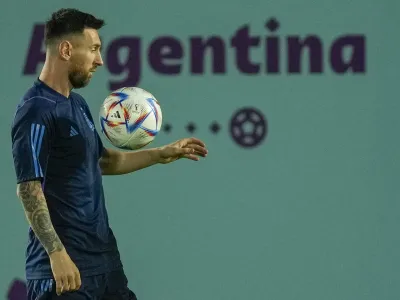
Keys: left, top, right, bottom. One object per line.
{"left": 287, "top": 35, "right": 323, "bottom": 73}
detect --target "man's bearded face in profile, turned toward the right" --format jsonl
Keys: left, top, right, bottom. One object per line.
{"left": 68, "top": 29, "right": 103, "bottom": 89}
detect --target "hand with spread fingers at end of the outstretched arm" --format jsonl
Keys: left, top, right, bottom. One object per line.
{"left": 158, "top": 138, "right": 208, "bottom": 164}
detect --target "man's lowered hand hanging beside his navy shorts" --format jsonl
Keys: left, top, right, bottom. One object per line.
{"left": 49, "top": 249, "right": 82, "bottom": 295}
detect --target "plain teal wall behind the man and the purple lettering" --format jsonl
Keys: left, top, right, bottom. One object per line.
{"left": 0, "top": 0, "right": 400, "bottom": 300}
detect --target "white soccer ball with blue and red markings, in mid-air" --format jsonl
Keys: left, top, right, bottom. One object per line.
{"left": 99, "top": 87, "right": 162, "bottom": 150}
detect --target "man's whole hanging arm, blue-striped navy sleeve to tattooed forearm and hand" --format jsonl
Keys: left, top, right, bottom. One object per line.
{"left": 11, "top": 97, "right": 81, "bottom": 295}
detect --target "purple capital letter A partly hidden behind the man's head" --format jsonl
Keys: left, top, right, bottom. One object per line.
{"left": 23, "top": 24, "right": 46, "bottom": 75}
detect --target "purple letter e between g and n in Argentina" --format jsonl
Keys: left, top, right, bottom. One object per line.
{"left": 148, "top": 37, "right": 183, "bottom": 74}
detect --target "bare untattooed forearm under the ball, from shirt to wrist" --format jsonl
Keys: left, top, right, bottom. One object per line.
{"left": 100, "top": 148, "right": 159, "bottom": 175}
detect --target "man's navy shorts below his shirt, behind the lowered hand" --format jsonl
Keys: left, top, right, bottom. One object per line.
{"left": 27, "top": 270, "right": 137, "bottom": 300}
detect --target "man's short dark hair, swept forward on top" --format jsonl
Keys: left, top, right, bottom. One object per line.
{"left": 45, "top": 8, "right": 105, "bottom": 45}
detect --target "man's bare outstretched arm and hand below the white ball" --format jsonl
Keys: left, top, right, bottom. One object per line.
{"left": 100, "top": 138, "right": 208, "bottom": 175}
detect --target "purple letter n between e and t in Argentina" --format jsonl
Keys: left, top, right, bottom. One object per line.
{"left": 190, "top": 36, "right": 226, "bottom": 74}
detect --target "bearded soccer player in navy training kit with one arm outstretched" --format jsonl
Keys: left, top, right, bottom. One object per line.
{"left": 11, "top": 9, "right": 207, "bottom": 300}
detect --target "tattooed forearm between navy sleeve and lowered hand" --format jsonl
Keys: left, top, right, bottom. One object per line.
{"left": 17, "top": 181, "right": 64, "bottom": 254}
